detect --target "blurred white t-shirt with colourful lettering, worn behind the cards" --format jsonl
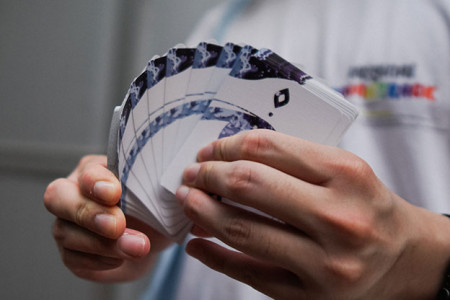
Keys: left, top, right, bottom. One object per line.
{"left": 144, "top": 0, "right": 450, "bottom": 300}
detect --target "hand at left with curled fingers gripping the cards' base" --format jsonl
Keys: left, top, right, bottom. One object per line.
{"left": 44, "top": 156, "right": 169, "bottom": 282}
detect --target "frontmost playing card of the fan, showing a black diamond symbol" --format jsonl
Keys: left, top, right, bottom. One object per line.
{"left": 161, "top": 47, "right": 356, "bottom": 193}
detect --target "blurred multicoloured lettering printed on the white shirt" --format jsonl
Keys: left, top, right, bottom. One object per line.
{"left": 335, "top": 63, "right": 444, "bottom": 129}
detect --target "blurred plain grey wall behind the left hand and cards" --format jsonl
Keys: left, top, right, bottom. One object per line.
{"left": 0, "top": 0, "right": 223, "bottom": 300}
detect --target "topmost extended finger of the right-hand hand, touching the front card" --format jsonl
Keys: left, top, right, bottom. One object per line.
{"left": 197, "top": 129, "right": 348, "bottom": 184}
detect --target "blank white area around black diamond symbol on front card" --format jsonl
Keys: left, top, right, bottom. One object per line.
{"left": 216, "top": 77, "right": 341, "bottom": 143}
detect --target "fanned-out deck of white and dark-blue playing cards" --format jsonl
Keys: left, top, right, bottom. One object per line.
{"left": 108, "top": 42, "right": 357, "bottom": 242}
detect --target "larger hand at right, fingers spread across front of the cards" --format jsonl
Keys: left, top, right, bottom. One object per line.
{"left": 177, "top": 130, "right": 450, "bottom": 299}
